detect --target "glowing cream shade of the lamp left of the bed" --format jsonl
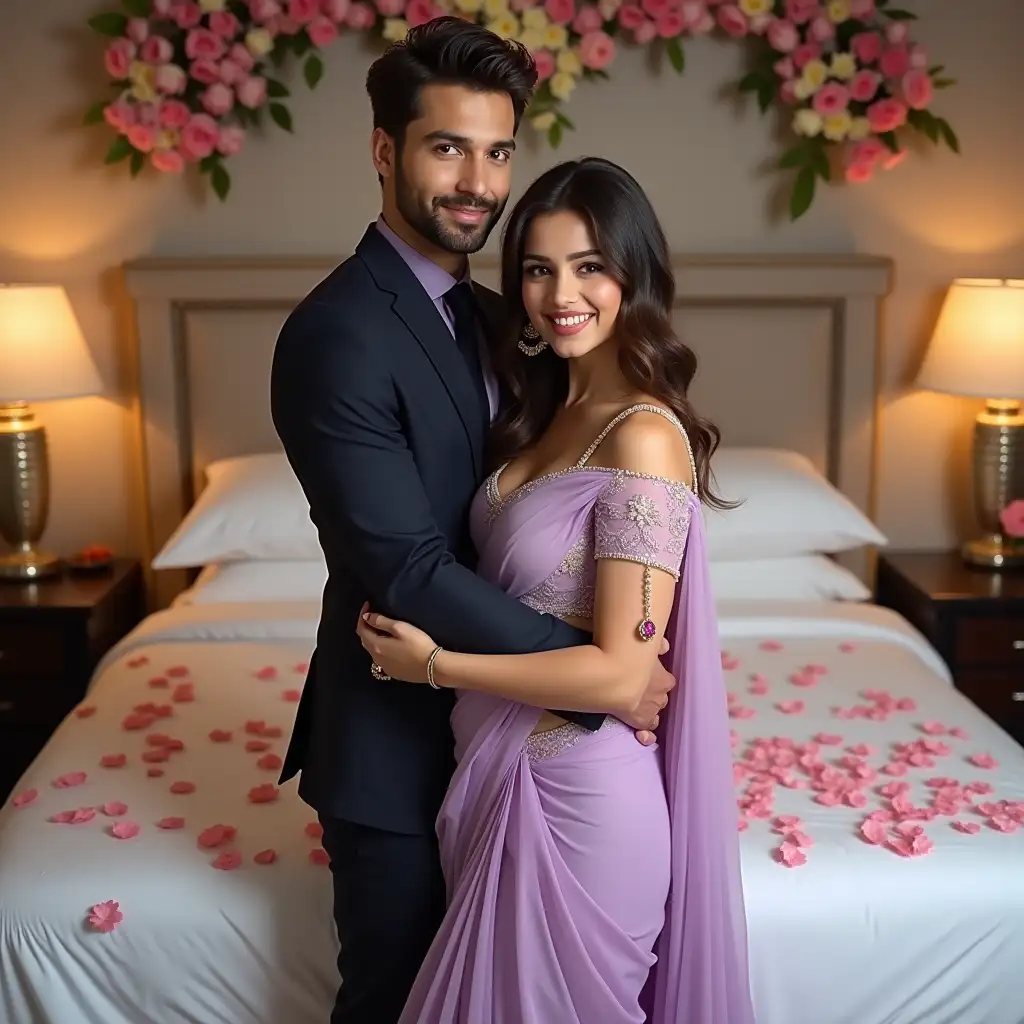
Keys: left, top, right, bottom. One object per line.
{"left": 0, "top": 285, "right": 102, "bottom": 402}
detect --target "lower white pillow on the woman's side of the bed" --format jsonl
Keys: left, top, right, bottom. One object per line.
{"left": 711, "top": 555, "right": 871, "bottom": 601}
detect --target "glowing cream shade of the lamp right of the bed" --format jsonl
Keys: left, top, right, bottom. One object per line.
{"left": 918, "top": 278, "right": 1024, "bottom": 399}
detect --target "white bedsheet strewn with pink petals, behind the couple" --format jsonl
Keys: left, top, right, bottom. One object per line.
{"left": 0, "top": 602, "right": 1024, "bottom": 1024}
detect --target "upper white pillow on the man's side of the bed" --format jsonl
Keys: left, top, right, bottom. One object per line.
{"left": 153, "top": 453, "right": 323, "bottom": 569}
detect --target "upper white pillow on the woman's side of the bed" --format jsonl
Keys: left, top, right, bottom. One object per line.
{"left": 705, "top": 447, "right": 888, "bottom": 561}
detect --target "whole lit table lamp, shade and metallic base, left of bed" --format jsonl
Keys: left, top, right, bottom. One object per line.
{"left": 0, "top": 285, "right": 101, "bottom": 581}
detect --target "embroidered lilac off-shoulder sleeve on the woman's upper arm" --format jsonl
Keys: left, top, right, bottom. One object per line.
{"left": 594, "top": 470, "right": 691, "bottom": 580}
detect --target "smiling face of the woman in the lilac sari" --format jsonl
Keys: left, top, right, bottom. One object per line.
{"left": 522, "top": 212, "right": 623, "bottom": 359}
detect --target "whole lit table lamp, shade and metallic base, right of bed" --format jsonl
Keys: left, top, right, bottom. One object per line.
{"left": 916, "top": 278, "right": 1024, "bottom": 568}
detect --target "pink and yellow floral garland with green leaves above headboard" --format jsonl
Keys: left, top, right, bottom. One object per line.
{"left": 85, "top": 0, "right": 959, "bottom": 219}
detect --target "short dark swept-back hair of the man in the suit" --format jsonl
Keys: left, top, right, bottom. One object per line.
{"left": 367, "top": 16, "right": 537, "bottom": 145}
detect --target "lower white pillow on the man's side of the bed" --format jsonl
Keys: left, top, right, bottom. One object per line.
{"left": 174, "top": 557, "right": 327, "bottom": 605}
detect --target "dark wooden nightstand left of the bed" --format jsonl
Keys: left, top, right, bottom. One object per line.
{"left": 0, "top": 559, "right": 145, "bottom": 804}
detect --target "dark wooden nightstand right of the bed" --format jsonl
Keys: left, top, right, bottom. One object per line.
{"left": 876, "top": 552, "right": 1024, "bottom": 743}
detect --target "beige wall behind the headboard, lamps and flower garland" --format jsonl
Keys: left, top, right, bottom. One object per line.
{"left": 0, "top": 0, "right": 1024, "bottom": 552}
